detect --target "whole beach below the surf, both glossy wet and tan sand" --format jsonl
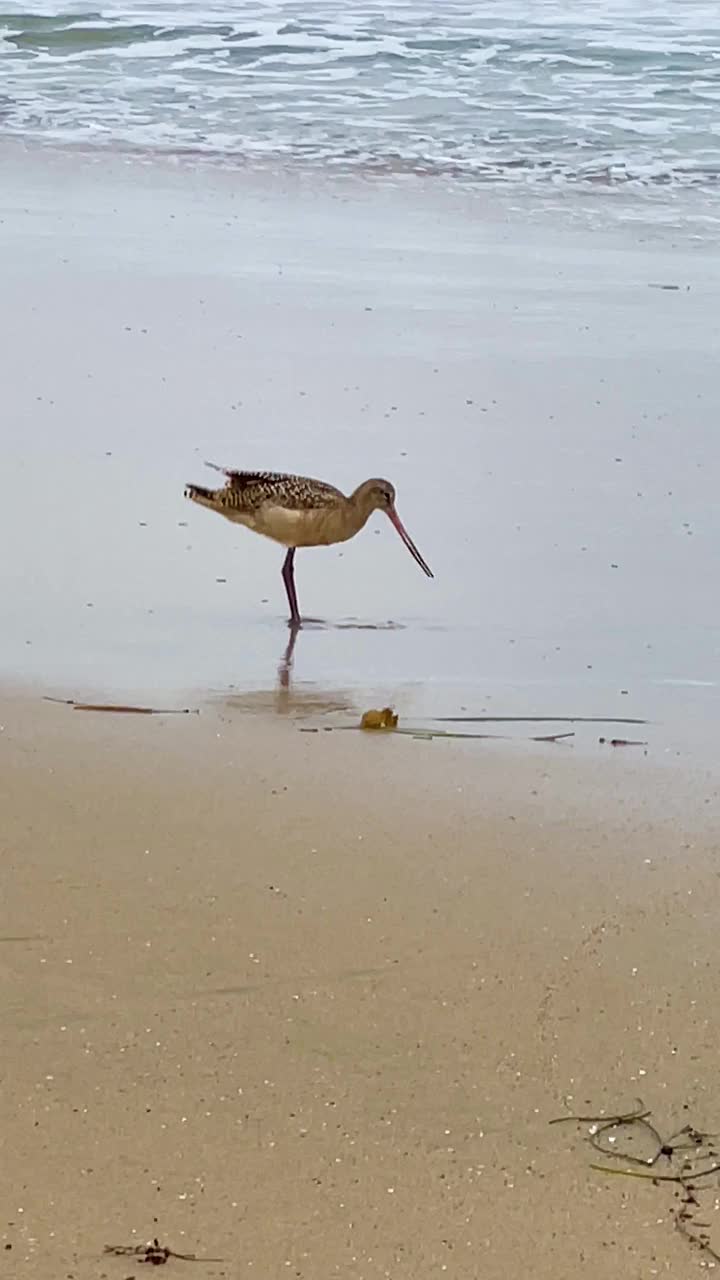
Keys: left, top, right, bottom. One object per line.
{"left": 0, "top": 140, "right": 720, "bottom": 1280}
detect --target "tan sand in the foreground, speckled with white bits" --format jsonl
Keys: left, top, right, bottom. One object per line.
{"left": 0, "top": 695, "right": 720, "bottom": 1280}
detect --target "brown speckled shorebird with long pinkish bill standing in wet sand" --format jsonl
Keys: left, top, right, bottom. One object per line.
{"left": 184, "top": 462, "right": 433, "bottom": 627}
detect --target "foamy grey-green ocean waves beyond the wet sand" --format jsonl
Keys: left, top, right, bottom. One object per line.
{"left": 0, "top": 0, "right": 720, "bottom": 189}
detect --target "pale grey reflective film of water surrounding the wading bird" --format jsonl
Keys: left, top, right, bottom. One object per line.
{"left": 0, "top": 159, "right": 720, "bottom": 750}
